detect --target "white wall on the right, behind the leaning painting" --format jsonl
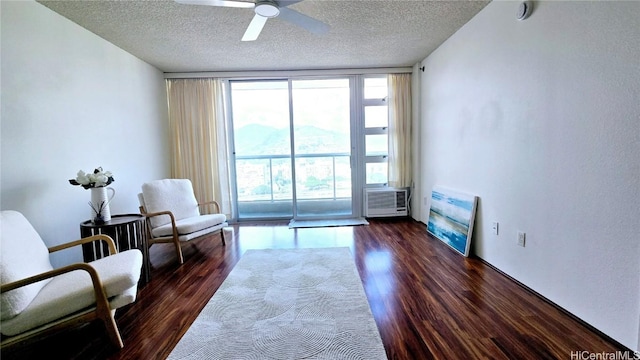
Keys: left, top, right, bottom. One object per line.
{"left": 420, "top": 1, "right": 640, "bottom": 349}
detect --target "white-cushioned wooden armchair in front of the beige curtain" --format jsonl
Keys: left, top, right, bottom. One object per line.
{"left": 138, "top": 179, "right": 228, "bottom": 264}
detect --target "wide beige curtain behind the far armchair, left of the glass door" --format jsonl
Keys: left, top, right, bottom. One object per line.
{"left": 167, "top": 79, "right": 232, "bottom": 216}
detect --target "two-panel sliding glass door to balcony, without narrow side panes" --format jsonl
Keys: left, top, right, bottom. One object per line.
{"left": 230, "top": 78, "right": 353, "bottom": 219}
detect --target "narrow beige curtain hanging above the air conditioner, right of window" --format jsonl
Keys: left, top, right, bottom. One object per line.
{"left": 388, "top": 74, "right": 412, "bottom": 187}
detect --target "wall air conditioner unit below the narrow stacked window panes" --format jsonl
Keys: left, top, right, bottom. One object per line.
{"left": 364, "top": 188, "right": 409, "bottom": 217}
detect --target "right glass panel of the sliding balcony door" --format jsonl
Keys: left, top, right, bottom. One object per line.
{"left": 292, "top": 79, "right": 352, "bottom": 218}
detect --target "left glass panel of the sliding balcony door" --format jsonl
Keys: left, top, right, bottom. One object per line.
{"left": 230, "top": 81, "right": 293, "bottom": 219}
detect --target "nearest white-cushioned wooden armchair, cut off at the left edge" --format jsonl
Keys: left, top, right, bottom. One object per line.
{"left": 0, "top": 210, "right": 142, "bottom": 348}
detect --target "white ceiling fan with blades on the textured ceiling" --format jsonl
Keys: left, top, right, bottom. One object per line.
{"left": 174, "top": 0, "right": 329, "bottom": 41}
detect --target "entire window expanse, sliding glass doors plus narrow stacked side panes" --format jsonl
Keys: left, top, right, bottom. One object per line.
{"left": 229, "top": 76, "right": 388, "bottom": 220}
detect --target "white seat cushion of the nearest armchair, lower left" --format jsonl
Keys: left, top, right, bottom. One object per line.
{"left": 2, "top": 249, "right": 142, "bottom": 336}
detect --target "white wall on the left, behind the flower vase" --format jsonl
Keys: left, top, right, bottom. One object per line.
{"left": 0, "top": 1, "right": 170, "bottom": 265}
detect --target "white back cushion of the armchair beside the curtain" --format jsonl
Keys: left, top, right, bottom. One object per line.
{"left": 142, "top": 179, "right": 200, "bottom": 228}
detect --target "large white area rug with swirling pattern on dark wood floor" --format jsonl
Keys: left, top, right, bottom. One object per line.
{"left": 169, "top": 248, "right": 387, "bottom": 360}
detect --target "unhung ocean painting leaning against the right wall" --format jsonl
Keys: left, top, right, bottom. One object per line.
{"left": 427, "top": 186, "right": 478, "bottom": 256}
